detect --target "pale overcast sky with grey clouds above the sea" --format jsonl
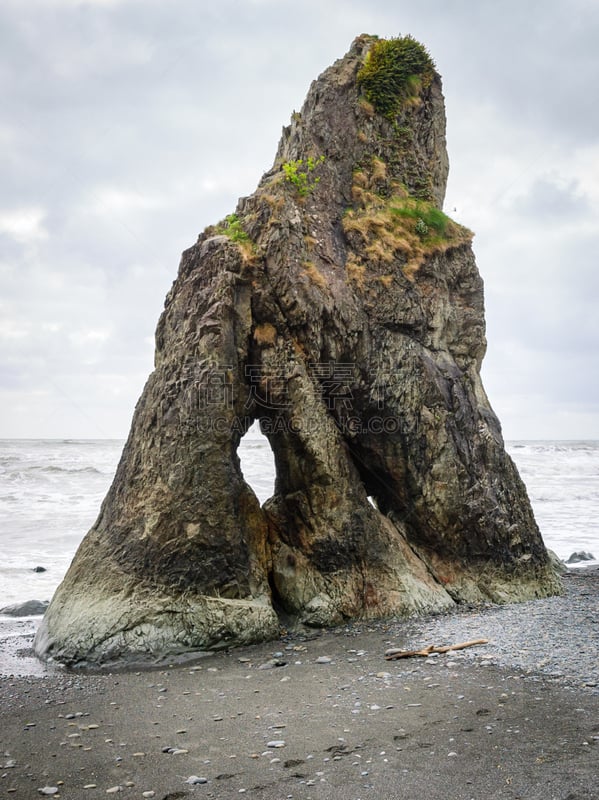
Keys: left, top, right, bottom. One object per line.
{"left": 0, "top": 0, "right": 599, "bottom": 439}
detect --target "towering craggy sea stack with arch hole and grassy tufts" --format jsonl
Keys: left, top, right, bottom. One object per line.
{"left": 36, "top": 36, "right": 560, "bottom": 664}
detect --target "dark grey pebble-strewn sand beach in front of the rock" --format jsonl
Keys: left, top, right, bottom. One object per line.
{"left": 0, "top": 569, "right": 599, "bottom": 800}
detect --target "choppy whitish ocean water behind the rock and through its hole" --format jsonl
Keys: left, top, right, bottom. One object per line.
{"left": 0, "top": 438, "right": 599, "bottom": 612}
